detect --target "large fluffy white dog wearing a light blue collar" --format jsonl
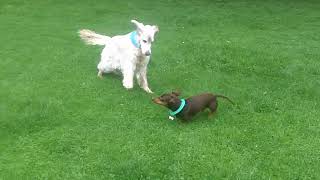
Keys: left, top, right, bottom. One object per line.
{"left": 79, "top": 20, "right": 159, "bottom": 93}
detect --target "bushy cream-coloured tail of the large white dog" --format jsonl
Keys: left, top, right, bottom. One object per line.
{"left": 79, "top": 29, "right": 111, "bottom": 45}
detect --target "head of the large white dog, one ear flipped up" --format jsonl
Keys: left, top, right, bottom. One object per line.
{"left": 131, "top": 20, "right": 159, "bottom": 56}
